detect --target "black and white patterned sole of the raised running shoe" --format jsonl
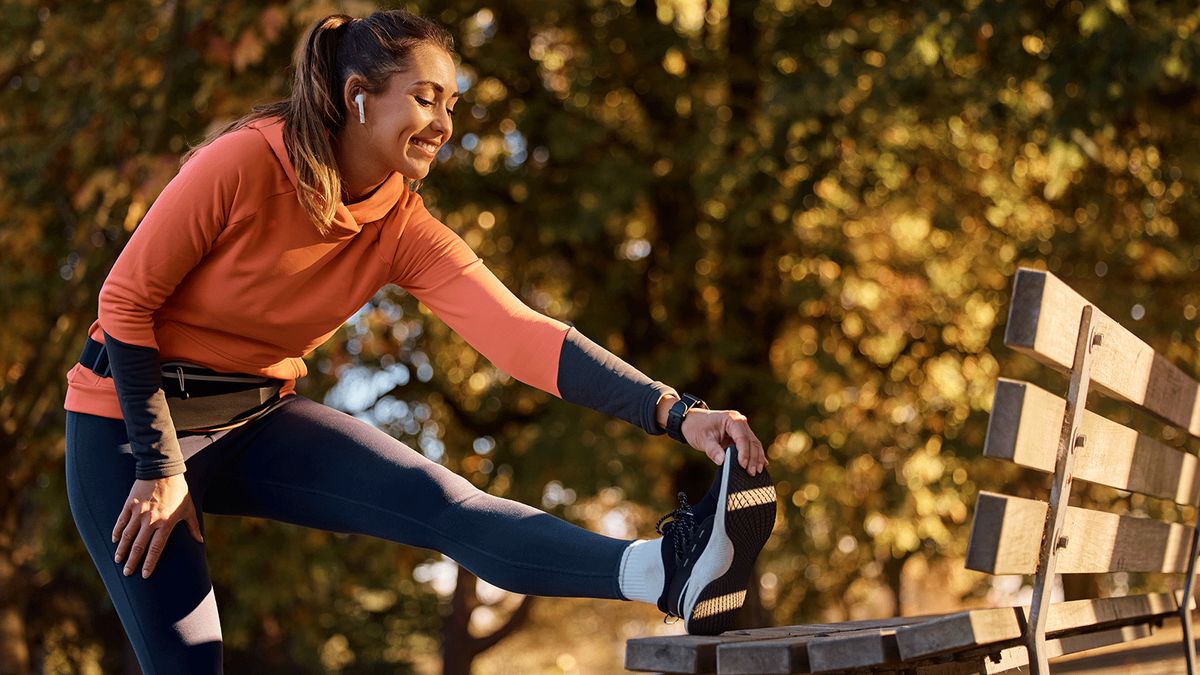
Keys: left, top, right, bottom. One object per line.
{"left": 680, "top": 449, "right": 775, "bottom": 635}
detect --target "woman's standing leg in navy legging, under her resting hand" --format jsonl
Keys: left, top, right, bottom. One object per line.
{"left": 66, "top": 412, "right": 221, "bottom": 675}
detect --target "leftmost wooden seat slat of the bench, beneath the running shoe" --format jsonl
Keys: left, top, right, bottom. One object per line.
{"left": 625, "top": 619, "right": 912, "bottom": 673}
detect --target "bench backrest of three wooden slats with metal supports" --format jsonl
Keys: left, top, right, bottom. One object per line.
{"left": 966, "top": 268, "right": 1200, "bottom": 673}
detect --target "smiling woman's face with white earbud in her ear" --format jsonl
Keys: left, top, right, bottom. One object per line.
{"left": 357, "top": 44, "right": 458, "bottom": 180}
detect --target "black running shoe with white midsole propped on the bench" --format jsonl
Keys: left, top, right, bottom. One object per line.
{"left": 659, "top": 446, "right": 775, "bottom": 635}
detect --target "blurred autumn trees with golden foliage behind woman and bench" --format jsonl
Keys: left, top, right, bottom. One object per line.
{"left": 0, "top": 0, "right": 1200, "bottom": 674}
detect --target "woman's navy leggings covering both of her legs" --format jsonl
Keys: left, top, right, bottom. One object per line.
{"left": 66, "top": 396, "right": 630, "bottom": 675}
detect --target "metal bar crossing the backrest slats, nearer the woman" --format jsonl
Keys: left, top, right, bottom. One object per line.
{"left": 1025, "top": 305, "right": 1100, "bottom": 675}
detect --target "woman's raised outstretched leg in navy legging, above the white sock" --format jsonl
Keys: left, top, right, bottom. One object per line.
{"left": 205, "top": 396, "right": 630, "bottom": 598}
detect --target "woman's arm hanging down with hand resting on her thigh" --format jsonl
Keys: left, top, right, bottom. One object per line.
{"left": 100, "top": 132, "right": 262, "bottom": 578}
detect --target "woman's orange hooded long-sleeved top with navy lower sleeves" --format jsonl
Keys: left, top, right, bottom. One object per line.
{"left": 65, "top": 119, "right": 673, "bottom": 478}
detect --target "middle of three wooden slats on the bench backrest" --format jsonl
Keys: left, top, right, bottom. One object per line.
{"left": 983, "top": 378, "right": 1200, "bottom": 506}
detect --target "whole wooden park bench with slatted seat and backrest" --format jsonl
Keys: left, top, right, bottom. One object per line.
{"left": 625, "top": 269, "right": 1200, "bottom": 675}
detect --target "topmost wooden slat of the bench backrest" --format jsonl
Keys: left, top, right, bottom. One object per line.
{"left": 1004, "top": 268, "right": 1200, "bottom": 436}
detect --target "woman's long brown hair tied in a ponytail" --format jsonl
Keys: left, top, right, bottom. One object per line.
{"left": 182, "top": 10, "right": 454, "bottom": 234}
